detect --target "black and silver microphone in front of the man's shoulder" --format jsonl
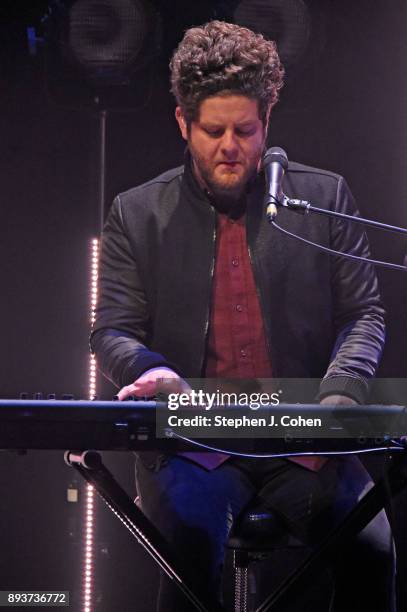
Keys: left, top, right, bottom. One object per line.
{"left": 263, "top": 147, "right": 288, "bottom": 222}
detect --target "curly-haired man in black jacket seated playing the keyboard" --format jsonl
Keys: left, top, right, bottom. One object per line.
{"left": 92, "top": 21, "right": 394, "bottom": 612}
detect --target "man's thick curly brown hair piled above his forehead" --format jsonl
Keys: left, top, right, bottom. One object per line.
{"left": 170, "top": 21, "right": 284, "bottom": 123}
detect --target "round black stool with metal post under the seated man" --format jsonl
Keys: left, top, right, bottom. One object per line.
{"left": 226, "top": 504, "right": 305, "bottom": 612}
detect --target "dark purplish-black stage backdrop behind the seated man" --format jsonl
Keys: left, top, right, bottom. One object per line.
{"left": 0, "top": 0, "right": 407, "bottom": 612}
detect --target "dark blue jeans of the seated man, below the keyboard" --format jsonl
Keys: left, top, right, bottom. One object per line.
{"left": 136, "top": 455, "right": 395, "bottom": 612}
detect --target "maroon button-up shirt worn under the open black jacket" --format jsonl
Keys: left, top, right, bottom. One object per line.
{"left": 182, "top": 214, "right": 271, "bottom": 469}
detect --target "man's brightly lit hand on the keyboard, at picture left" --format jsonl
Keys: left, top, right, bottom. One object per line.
{"left": 117, "top": 367, "right": 191, "bottom": 400}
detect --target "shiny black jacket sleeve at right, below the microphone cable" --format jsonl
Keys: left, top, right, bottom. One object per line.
{"left": 320, "top": 178, "right": 385, "bottom": 403}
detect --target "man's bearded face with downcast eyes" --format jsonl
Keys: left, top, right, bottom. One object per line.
{"left": 176, "top": 94, "right": 267, "bottom": 199}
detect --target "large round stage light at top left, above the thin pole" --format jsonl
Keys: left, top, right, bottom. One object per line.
{"left": 44, "top": 0, "right": 161, "bottom": 109}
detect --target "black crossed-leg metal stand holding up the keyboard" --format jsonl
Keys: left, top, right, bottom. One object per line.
{"left": 65, "top": 444, "right": 407, "bottom": 612}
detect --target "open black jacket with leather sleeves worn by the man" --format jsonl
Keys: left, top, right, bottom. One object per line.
{"left": 91, "top": 154, "right": 384, "bottom": 402}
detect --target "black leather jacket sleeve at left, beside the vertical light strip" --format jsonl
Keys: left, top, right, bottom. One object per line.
{"left": 90, "top": 196, "right": 172, "bottom": 387}
